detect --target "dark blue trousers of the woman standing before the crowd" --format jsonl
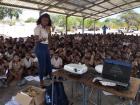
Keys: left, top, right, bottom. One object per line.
{"left": 35, "top": 43, "right": 52, "bottom": 80}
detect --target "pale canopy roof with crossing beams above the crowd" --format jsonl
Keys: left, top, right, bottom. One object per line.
{"left": 0, "top": 0, "right": 140, "bottom": 19}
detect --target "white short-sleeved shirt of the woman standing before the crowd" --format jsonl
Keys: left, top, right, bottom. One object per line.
{"left": 34, "top": 25, "right": 48, "bottom": 44}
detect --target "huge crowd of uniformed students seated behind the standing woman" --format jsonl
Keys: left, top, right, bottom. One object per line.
{"left": 0, "top": 33, "right": 140, "bottom": 84}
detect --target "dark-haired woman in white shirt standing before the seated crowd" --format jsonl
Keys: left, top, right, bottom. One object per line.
{"left": 34, "top": 13, "right": 52, "bottom": 88}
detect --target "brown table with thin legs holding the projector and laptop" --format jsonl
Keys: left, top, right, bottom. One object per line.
{"left": 53, "top": 70, "right": 140, "bottom": 105}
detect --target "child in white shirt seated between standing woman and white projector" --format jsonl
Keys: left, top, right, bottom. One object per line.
{"left": 51, "top": 52, "right": 63, "bottom": 69}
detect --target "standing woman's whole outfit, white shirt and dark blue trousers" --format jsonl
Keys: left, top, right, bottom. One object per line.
{"left": 34, "top": 25, "right": 52, "bottom": 80}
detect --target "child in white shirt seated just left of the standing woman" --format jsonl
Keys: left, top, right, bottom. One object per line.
{"left": 22, "top": 53, "right": 34, "bottom": 75}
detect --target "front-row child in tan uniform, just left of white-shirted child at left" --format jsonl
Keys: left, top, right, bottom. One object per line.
{"left": 7, "top": 54, "right": 23, "bottom": 84}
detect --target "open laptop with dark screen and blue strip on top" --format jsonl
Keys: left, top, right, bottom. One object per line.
{"left": 102, "top": 59, "right": 132, "bottom": 88}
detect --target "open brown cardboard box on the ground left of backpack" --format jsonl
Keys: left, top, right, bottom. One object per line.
{"left": 16, "top": 86, "right": 45, "bottom": 105}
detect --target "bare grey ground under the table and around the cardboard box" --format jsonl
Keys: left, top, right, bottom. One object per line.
{"left": 0, "top": 80, "right": 140, "bottom": 105}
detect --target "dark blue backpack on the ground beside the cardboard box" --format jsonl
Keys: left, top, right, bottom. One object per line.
{"left": 45, "top": 82, "right": 69, "bottom": 105}
